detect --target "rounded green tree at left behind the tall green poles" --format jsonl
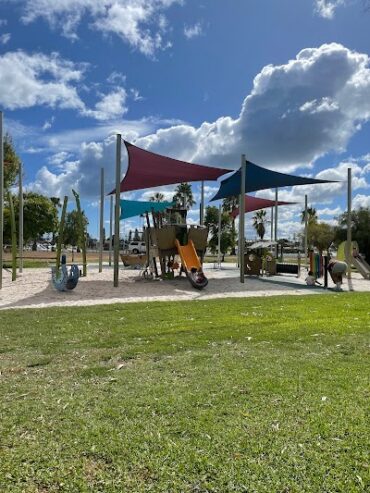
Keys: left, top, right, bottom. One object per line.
{"left": 4, "top": 192, "right": 58, "bottom": 249}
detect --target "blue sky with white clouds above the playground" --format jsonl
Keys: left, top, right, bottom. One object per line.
{"left": 0, "top": 0, "right": 370, "bottom": 236}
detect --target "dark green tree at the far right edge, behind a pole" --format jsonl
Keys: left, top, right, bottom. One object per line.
{"left": 334, "top": 207, "right": 370, "bottom": 262}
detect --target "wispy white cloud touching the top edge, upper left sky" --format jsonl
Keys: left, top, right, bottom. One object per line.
{"left": 14, "top": 0, "right": 182, "bottom": 56}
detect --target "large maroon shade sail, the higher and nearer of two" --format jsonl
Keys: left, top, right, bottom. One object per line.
{"left": 110, "top": 141, "right": 231, "bottom": 194}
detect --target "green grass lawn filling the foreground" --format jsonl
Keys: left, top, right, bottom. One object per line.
{"left": 0, "top": 294, "right": 370, "bottom": 493}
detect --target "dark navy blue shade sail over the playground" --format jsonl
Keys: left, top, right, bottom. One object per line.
{"left": 212, "top": 161, "right": 333, "bottom": 200}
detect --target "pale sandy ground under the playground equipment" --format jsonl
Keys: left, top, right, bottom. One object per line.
{"left": 0, "top": 264, "right": 370, "bottom": 309}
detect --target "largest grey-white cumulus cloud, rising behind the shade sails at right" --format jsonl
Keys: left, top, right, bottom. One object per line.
{"left": 27, "top": 43, "right": 370, "bottom": 204}
